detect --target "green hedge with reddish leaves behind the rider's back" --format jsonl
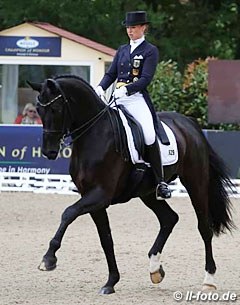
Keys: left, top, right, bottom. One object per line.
{"left": 148, "top": 58, "right": 240, "bottom": 130}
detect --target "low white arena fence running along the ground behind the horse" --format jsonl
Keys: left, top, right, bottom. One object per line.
{"left": 0, "top": 172, "right": 240, "bottom": 198}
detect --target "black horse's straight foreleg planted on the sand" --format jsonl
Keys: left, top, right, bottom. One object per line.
{"left": 91, "top": 209, "right": 120, "bottom": 294}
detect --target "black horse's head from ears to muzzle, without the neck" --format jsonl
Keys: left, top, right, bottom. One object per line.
{"left": 28, "top": 79, "right": 69, "bottom": 160}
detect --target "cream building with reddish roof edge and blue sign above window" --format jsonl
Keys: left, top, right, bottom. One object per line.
{"left": 0, "top": 22, "right": 115, "bottom": 124}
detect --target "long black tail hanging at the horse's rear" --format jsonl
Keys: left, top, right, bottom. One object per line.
{"left": 208, "top": 144, "right": 235, "bottom": 235}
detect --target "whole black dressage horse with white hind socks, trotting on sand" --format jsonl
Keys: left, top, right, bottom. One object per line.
{"left": 28, "top": 75, "right": 234, "bottom": 294}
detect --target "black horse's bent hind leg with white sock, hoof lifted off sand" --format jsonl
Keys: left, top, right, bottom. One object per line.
{"left": 141, "top": 194, "right": 179, "bottom": 284}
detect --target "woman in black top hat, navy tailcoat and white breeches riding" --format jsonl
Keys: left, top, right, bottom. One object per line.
{"left": 95, "top": 11, "right": 171, "bottom": 200}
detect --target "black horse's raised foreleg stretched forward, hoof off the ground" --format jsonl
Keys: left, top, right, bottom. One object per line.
{"left": 38, "top": 188, "right": 108, "bottom": 271}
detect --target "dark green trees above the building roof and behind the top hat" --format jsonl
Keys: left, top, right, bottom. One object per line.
{"left": 0, "top": 0, "right": 240, "bottom": 66}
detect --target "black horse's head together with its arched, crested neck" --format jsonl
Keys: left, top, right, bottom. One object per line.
{"left": 28, "top": 75, "right": 106, "bottom": 160}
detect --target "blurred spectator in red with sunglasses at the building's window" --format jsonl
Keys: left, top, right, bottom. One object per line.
{"left": 14, "top": 103, "right": 42, "bottom": 124}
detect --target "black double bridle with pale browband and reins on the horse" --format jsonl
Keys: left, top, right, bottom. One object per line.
{"left": 36, "top": 79, "right": 113, "bottom": 149}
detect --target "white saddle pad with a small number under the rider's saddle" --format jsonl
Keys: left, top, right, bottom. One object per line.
{"left": 119, "top": 109, "right": 178, "bottom": 165}
